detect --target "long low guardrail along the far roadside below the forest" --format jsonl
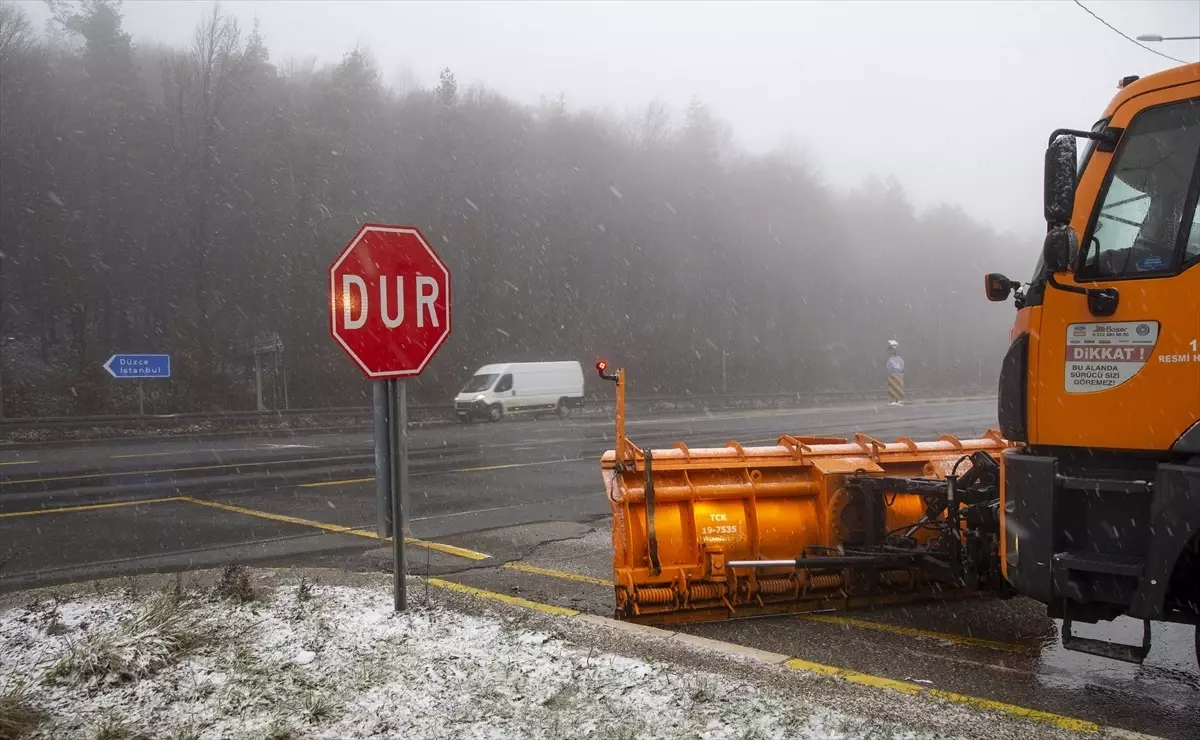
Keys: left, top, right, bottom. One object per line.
{"left": 0, "top": 389, "right": 990, "bottom": 435}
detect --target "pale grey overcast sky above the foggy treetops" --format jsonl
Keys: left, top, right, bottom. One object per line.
{"left": 25, "top": 0, "right": 1200, "bottom": 234}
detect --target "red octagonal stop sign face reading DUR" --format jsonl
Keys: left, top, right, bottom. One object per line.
{"left": 329, "top": 223, "right": 450, "bottom": 379}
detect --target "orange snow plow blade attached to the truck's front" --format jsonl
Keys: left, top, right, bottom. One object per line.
{"left": 598, "top": 366, "right": 1008, "bottom": 624}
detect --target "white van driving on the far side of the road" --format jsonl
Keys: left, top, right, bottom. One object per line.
{"left": 454, "top": 362, "right": 583, "bottom": 421}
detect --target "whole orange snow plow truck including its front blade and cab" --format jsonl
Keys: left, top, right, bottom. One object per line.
{"left": 596, "top": 64, "right": 1200, "bottom": 662}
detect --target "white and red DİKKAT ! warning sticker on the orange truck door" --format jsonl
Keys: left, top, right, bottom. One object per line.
{"left": 1066, "top": 321, "right": 1158, "bottom": 393}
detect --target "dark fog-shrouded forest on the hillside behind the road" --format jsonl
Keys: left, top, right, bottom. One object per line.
{"left": 0, "top": 0, "right": 1040, "bottom": 416}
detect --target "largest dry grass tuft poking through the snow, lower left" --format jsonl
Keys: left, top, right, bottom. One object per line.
{"left": 47, "top": 592, "right": 211, "bottom": 686}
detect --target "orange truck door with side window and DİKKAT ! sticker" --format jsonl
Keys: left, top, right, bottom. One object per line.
{"left": 1030, "top": 92, "right": 1200, "bottom": 451}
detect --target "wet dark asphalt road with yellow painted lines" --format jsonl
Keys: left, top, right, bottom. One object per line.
{"left": 0, "top": 401, "right": 1200, "bottom": 738}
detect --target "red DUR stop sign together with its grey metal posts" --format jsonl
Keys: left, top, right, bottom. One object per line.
{"left": 329, "top": 223, "right": 450, "bottom": 612}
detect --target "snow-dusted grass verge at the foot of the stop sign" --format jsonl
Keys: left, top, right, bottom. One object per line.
{"left": 0, "top": 580, "right": 950, "bottom": 740}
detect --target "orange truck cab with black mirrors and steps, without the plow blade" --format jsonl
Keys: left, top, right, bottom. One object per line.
{"left": 986, "top": 64, "right": 1200, "bottom": 662}
